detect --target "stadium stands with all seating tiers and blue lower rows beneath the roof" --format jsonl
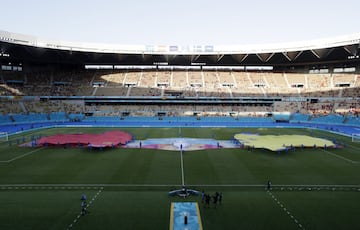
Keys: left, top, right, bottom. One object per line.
{"left": 0, "top": 30, "right": 360, "bottom": 135}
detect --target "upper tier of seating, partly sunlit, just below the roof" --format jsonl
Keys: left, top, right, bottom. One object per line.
{"left": 0, "top": 70, "right": 360, "bottom": 98}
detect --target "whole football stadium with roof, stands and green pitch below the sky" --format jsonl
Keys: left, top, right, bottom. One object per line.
{"left": 0, "top": 31, "right": 360, "bottom": 230}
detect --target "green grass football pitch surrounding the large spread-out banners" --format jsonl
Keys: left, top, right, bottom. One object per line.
{"left": 0, "top": 128, "right": 360, "bottom": 230}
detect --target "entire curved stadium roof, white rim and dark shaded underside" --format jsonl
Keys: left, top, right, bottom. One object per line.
{"left": 0, "top": 30, "right": 360, "bottom": 66}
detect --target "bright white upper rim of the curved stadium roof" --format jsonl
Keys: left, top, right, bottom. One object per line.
{"left": 0, "top": 30, "right": 360, "bottom": 55}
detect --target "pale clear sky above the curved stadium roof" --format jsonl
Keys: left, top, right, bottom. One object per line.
{"left": 0, "top": 0, "right": 360, "bottom": 45}
